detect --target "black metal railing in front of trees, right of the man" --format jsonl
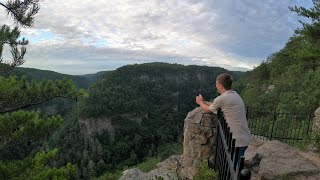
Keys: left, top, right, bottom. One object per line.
{"left": 246, "top": 106, "right": 313, "bottom": 144}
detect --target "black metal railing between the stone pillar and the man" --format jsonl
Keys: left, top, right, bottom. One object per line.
{"left": 213, "top": 109, "right": 251, "bottom": 180}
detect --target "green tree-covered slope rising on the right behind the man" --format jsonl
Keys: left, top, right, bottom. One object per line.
{"left": 237, "top": 0, "right": 320, "bottom": 112}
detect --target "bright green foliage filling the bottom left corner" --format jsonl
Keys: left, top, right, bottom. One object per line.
{"left": 0, "top": 149, "right": 76, "bottom": 180}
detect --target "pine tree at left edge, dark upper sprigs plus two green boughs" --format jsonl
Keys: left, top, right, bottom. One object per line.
{"left": 0, "top": 0, "right": 78, "bottom": 169}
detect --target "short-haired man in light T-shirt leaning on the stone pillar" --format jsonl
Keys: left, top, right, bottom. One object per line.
{"left": 196, "top": 74, "right": 251, "bottom": 170}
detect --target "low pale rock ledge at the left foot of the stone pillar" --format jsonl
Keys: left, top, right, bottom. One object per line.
{"left": 120, "top": 155, "right": 182, "bottom": 180}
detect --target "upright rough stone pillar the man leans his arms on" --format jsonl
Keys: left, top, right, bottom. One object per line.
{"left": 179, "top": 107, "right": 216, "bottom": 179}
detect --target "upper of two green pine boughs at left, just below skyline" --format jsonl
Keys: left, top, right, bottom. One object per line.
{"left": 0, "top": 76, "right": 79, "bottom": 113}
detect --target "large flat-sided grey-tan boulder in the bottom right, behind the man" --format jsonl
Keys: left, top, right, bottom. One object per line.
{"left": 245, "top": 139, "right": 319, "bottom": 180}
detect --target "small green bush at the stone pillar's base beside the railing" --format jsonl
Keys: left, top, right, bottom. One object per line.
{"left": 193, "top": 161, "right": 219, "bottom": 180}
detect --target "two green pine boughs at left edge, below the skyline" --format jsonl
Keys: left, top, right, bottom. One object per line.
{"left": 0, "top": 76, "right": 78, "bottom": 150}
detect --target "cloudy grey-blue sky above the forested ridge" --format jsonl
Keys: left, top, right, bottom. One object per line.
{"left": 0, "top": 0, "right": 312, "bottom": 75}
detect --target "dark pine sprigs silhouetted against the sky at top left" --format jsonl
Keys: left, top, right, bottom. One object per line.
{"left": 0, "top": 0, "right": 40, "bottom": 72}
